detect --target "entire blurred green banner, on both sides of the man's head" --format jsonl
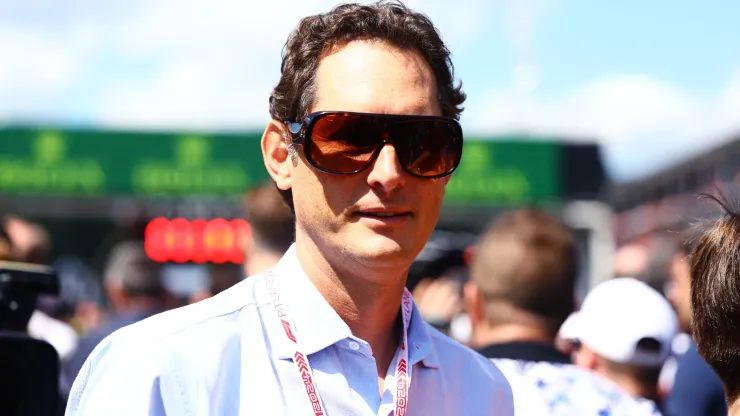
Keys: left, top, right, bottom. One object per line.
{"left": 0, "top": 128, "right": 561, "bottom": 205}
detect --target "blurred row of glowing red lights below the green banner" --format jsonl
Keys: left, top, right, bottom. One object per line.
{"left": 144, "top": 217, "right": 250, "bottom": 264}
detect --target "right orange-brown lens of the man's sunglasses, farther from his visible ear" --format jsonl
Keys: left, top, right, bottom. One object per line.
{"left": 392, "top": 120, "right": 462, "bottom": 177}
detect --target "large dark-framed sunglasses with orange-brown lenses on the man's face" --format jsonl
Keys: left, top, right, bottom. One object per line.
{"left": 285, "top": 111, "right": 463, "bottom": 178}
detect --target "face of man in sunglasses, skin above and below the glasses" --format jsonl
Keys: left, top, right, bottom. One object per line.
{"left": 274, "top": 41, "right": 447, "bottom": 270}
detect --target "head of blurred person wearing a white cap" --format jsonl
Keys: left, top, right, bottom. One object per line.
{"left": 560, "top": 277, "right": 678, "bottom": 410}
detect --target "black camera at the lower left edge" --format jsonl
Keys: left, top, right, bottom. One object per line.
{"left": 0, "top": 261, "right": 61, "bottom": 416}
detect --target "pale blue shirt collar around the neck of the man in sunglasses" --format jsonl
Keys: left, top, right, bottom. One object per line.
{"left": 268, "top": 243, "right": 439, "bottom": 368}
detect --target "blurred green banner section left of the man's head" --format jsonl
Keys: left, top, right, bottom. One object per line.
{"left": 0, "top": 129, "right": 267, "bottom": 195}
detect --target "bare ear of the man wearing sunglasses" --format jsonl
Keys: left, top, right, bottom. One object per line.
{"left": 262, "top": 120, "right": 292, "bottom": 191}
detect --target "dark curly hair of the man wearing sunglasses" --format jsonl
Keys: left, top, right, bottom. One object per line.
{"left": 270, "top": 0, "right": 466, "bottom": 211}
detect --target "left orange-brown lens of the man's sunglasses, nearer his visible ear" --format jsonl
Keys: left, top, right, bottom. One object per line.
{"left": 308, "top": 114, "right": 384, "bottom": 173}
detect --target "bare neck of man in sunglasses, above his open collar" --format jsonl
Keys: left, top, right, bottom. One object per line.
{"left": 296, "top": 232, "right": 406, "bottom": 382}
